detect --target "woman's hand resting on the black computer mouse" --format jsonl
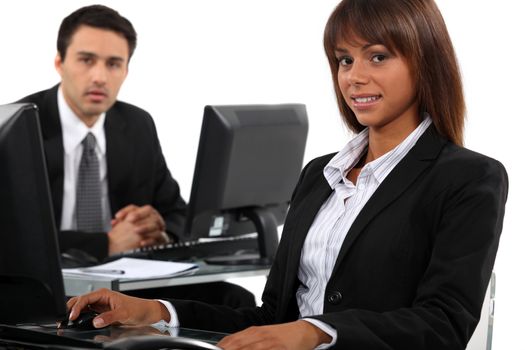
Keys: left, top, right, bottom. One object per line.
{"left": 67, "top": 289, "right": 170, "bottom": 328}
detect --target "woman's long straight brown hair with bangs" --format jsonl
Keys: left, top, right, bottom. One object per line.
{"left": 324, "top": 0, "right": 465, "bottom": 145}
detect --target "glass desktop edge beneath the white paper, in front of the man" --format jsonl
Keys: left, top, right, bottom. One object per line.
{"left": 63, "top": 262, "right": 269, "bottom": 296}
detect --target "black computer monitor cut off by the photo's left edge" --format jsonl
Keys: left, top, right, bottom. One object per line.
{"left": 0, "top": 103, "right": 66, "bottom": 324}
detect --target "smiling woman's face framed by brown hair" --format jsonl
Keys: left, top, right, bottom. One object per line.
{"left": 335, "top": 39, "right": 420, "bottom": 134}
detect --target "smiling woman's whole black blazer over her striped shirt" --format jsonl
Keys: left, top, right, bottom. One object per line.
{"left": 172, "top": 126, "right": 508, "bottom": 350}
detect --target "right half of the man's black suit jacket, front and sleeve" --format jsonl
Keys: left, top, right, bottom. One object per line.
{"left": 105, "top": 102, "right": 186, "bottom": 242}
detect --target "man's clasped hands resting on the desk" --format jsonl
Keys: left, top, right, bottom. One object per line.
{"left": 108, "top": 204, "right": 169, "bottom": 254}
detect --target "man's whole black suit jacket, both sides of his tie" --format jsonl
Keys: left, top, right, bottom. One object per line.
{"left": 19, "top": 85, "right": 186, "bottom": 258}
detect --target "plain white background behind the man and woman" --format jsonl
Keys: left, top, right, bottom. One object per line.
{"left": 0, "top": 0, "right": 525, "bottom": 350}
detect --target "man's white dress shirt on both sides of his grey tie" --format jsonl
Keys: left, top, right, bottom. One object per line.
{"left": 57, "top": 87, "right": 111, "bottom": 232}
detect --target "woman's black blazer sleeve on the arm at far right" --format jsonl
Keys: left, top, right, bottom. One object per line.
{"left": 314, "top": 160, "right": 508, "bottom": 350}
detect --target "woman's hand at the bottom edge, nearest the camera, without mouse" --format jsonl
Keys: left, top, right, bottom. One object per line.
{"left": 217, "top": 320, "right": 332, "bottom": 350}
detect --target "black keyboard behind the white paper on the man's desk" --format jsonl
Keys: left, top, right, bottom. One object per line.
{"left": 105, "top": 234, "right": 258, "bottom": 262}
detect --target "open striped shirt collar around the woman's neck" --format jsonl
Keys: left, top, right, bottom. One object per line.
{"left": 323, "top": 113, "right": 432, "bottom": 189}
